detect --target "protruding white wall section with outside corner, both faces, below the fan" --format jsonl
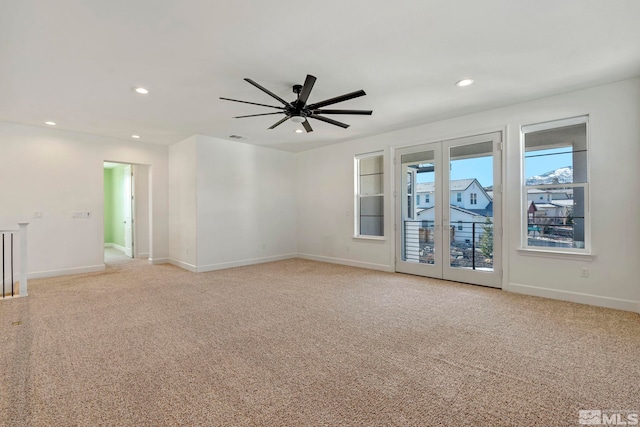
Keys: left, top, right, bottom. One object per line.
{"left": 169, "top": 135, "right": 297, "bottom": 272}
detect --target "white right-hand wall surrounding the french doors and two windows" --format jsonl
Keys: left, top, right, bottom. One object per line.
{"left": 297, "top": 79, "right": 640, "bottom": 311}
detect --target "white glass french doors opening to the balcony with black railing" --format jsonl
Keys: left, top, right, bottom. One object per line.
{"left": 394, "top": 132, "right": 502, "bottom": 287}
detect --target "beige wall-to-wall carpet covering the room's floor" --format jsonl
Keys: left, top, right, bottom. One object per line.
{"left": 0, "top": 260, "right": 640, "bottom": 426}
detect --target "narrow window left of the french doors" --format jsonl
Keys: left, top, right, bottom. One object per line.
{"left": 355, "top": 153, "right": 384, "bottom": 237}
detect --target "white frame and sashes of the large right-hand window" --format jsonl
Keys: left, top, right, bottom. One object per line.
{"left": 518, "top": 115, "right": 592, "bottom": 257}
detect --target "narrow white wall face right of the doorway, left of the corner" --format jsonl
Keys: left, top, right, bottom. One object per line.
{"left": 169, "top": 136, "right": 197, "bottom": 271}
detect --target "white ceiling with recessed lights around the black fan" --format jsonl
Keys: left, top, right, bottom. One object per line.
{"left": 0, "top": 0, "right": 640, "bottom": 152}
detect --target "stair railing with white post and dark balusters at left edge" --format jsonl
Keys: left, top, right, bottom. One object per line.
{"left": 0, "top": 223, "right": 28, "bottom": 299}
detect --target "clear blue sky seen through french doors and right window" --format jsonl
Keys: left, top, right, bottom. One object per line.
{"left": 418, "top": 147, "right": 572, "bottom": 187}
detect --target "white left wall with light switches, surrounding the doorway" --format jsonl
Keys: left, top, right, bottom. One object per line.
{"left": 0, "top": 122, "right": 168, "bottom": 277}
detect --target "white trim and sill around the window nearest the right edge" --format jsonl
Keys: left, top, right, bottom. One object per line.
{"left": 517, "top": 114, "right": 595, "bottom": 254}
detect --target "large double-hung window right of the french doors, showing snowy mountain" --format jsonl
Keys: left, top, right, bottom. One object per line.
{"left": 522, "top": 116, "right": 590, "bottom": 253}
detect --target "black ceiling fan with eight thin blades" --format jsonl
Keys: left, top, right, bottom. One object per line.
{"left": 220, "top": 74, "right": 373, "bottom": 132}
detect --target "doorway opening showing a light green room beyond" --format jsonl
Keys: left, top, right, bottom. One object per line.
{"left": 103, "top": 162, "right": 150, "bottom": 265}
